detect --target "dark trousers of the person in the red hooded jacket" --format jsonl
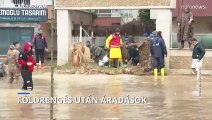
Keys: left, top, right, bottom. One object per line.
{"left": 21, "top": 70, "right": 33, "bottom": 91}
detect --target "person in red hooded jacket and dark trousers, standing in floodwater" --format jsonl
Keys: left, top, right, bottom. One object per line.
{"left": 18, "top": 42, "right": 36, "bottom": 91}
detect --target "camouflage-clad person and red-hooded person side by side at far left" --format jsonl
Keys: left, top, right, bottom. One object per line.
{"left": 5, "top": 42, "right": 36, "bottom": 90}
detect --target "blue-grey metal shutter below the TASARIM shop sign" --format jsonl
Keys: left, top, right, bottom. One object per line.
{"left": 0, "top": 27, "right": 34, "bottom": 55}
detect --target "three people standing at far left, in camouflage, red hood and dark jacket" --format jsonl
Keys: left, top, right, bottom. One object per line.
{"left": 5, "top": 28, "right": 48, "bottom": 90}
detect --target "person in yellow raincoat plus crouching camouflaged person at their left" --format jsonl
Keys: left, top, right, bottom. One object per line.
{"left": 86, "top": 28, "right": 123, "bottom": 67}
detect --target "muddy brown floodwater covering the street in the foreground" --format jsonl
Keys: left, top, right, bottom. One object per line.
{"left": 0, "top": 72, "right": 212, "bottom": 120}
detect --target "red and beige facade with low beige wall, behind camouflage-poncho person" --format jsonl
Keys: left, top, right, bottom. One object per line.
{"left": 170, "top": 0, "right": 212, "bottom": 74}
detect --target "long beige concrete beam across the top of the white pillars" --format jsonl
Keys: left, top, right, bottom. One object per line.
{"left": 56, "top": 0, "right": 173, "bottom": 9}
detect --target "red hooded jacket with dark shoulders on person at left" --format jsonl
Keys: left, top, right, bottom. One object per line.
{"left": 18, "top": 42, "right": 36, "bottom": 72}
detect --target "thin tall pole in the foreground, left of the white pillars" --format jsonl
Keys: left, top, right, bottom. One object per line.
{"left": 50, "top": 0, "right": 55, "bottom": 120}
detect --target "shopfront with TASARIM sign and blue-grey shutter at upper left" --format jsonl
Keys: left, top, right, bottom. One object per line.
{"left": 0, "top": 0, "right": 51, "bottom": 55}
